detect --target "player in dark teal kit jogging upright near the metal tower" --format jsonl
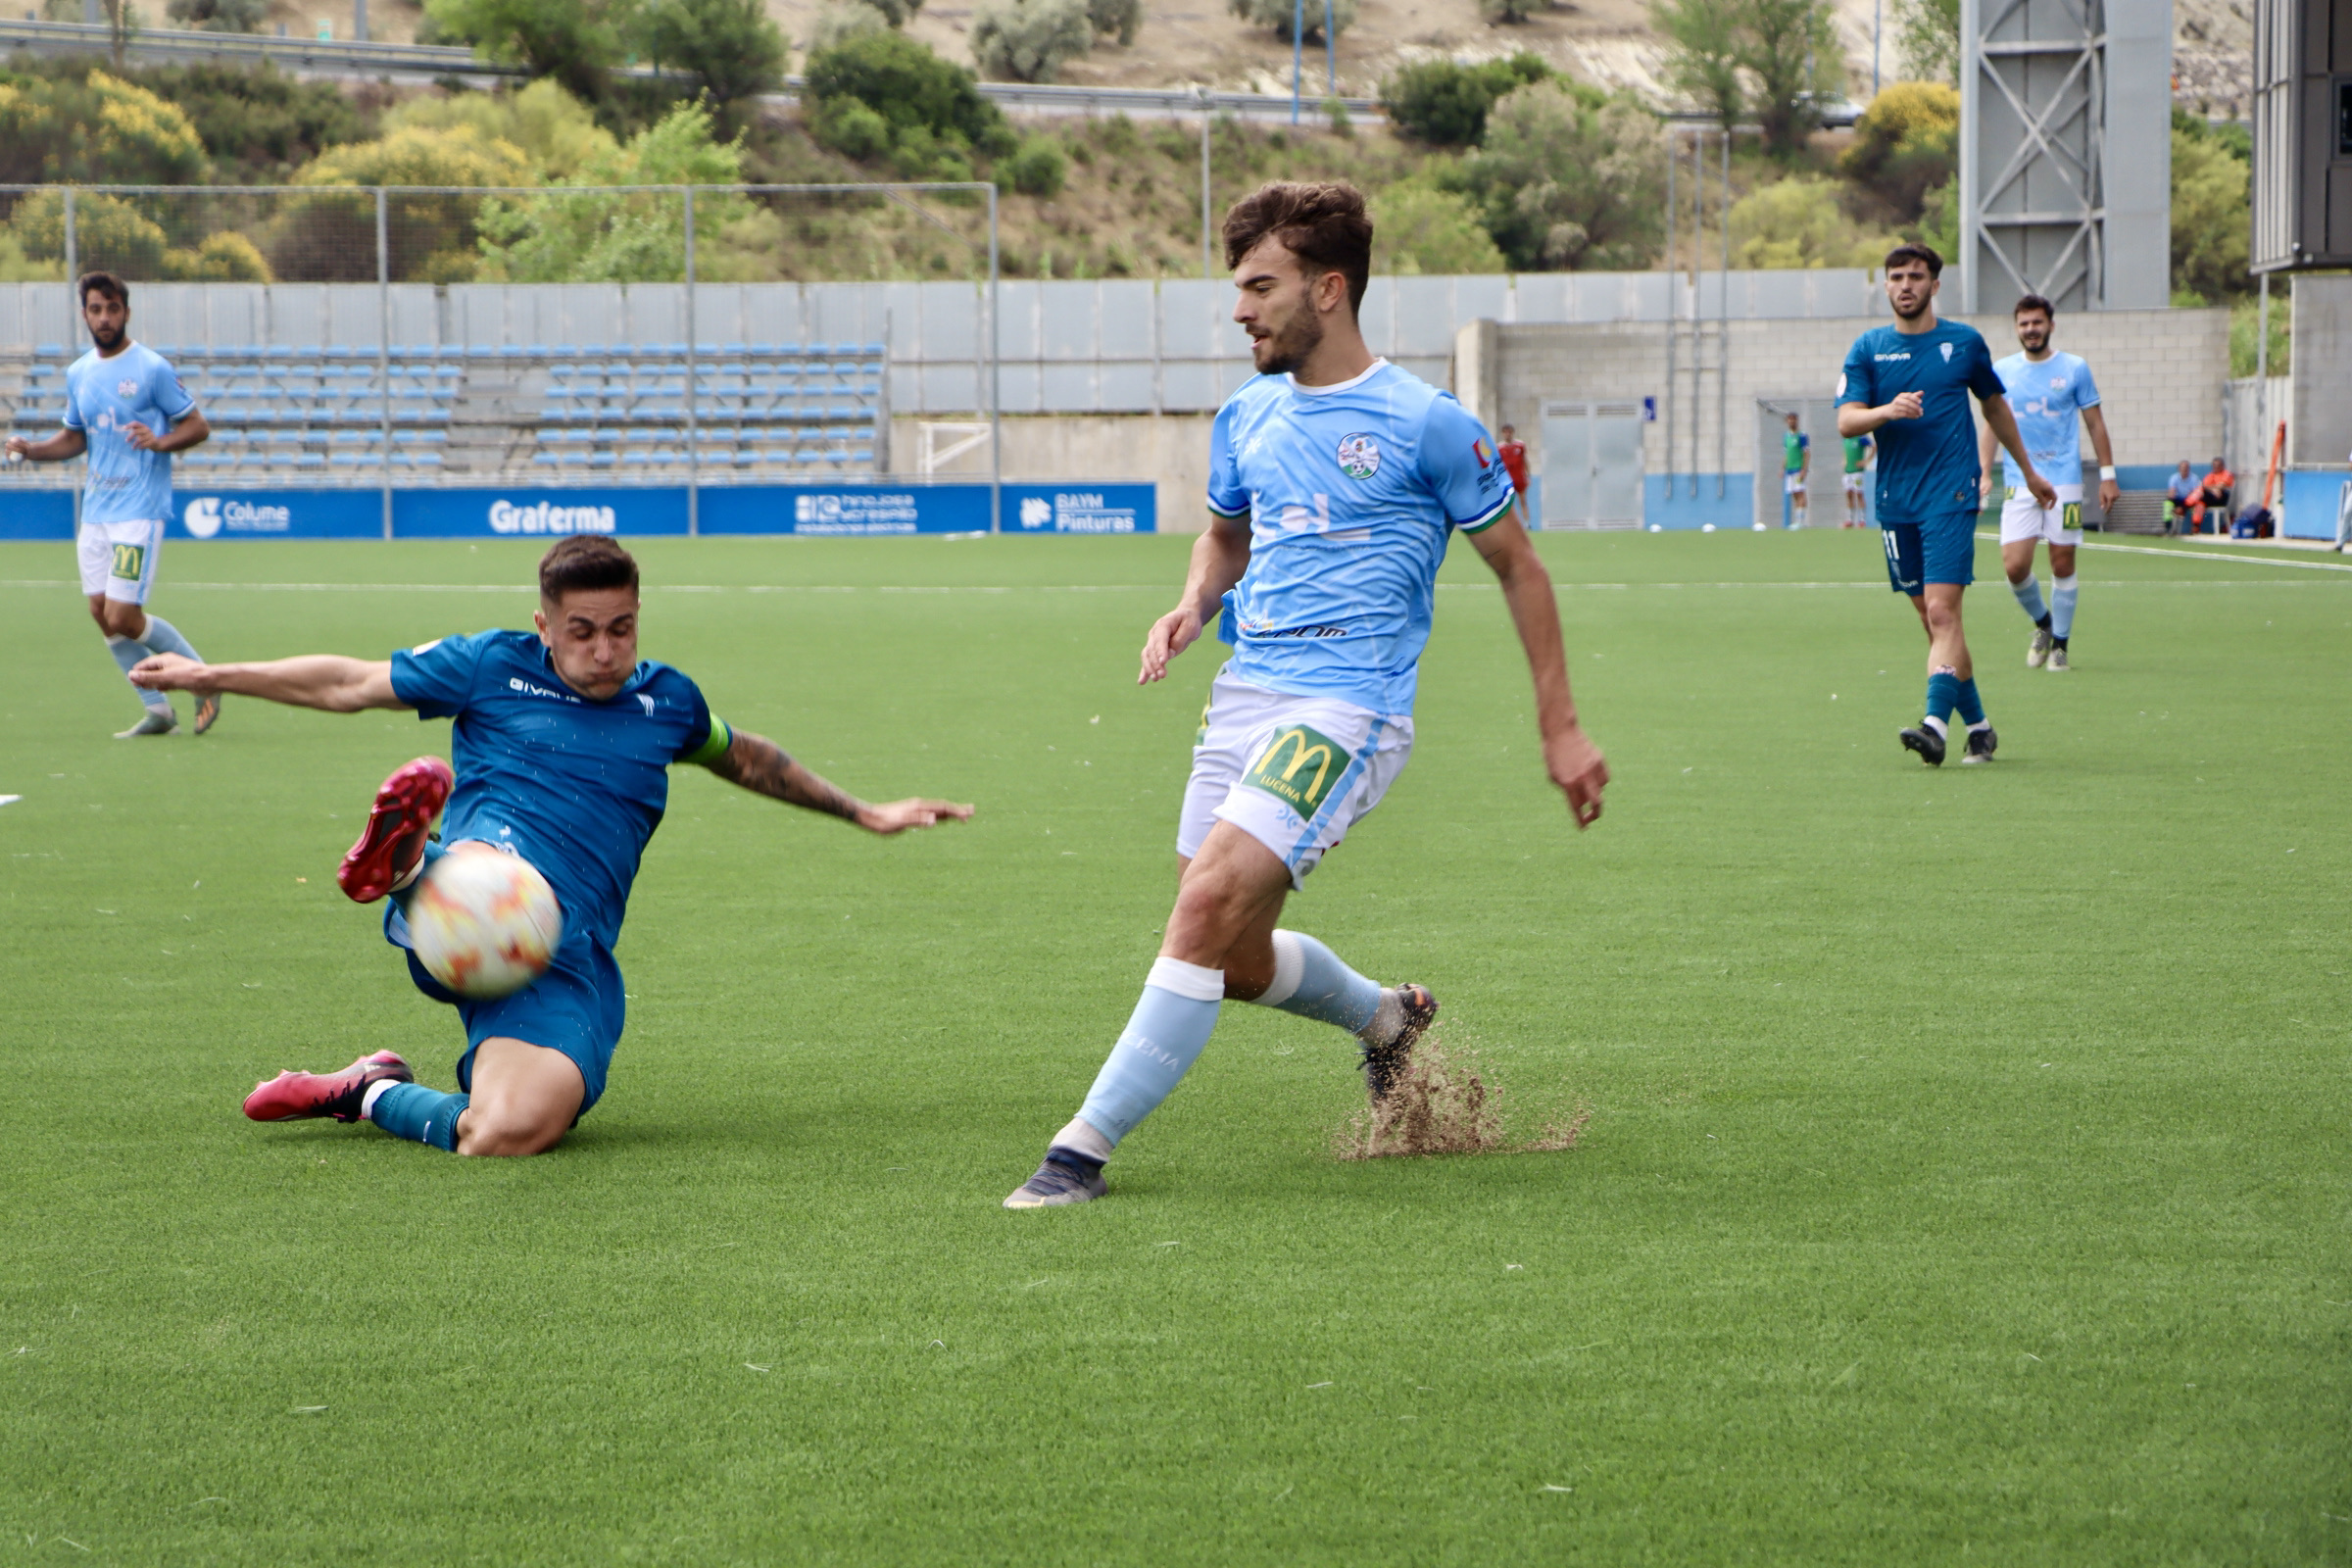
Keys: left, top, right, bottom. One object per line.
{"left": 1837, "top": 244, "right": 2058, "bottom": 766}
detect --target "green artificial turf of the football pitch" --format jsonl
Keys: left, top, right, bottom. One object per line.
{"left": 0, "top": 531, "right": 2352, "bottom": 1568}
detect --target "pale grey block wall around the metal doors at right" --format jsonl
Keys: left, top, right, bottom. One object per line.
{"left": 1453, "top": 305, "right": 2230, "bottom": 521}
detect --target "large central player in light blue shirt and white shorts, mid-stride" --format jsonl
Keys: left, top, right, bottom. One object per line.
{"left": 1004, "top": 183, "right": 1609, "bottom": 1208}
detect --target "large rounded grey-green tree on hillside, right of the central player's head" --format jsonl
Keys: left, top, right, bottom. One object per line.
{"left": 1460, "top": 82, "right": 1665, "bottom": 270}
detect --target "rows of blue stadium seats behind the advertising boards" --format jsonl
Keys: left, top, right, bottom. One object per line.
{"left": 0, "top": 343, "right": 889, "bottom": 484}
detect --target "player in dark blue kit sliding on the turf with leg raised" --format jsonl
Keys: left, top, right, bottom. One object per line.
{"left": 139, "top": 536, "right": 971, "bottom": 1154}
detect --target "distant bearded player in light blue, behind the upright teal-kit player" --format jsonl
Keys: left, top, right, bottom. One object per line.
{"left": 1978, "top": 294, "right": 2124, "bottom": 670}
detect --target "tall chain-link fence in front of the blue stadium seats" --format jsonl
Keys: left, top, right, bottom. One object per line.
{"left": 0, "top": 183, "right": 1000, "bottom": 503}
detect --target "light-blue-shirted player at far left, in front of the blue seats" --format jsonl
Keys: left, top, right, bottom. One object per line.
{"left": 7, "top": 272, "right": 221, "bottom": 741}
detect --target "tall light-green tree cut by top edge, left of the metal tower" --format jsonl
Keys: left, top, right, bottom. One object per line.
{"left": 1656, "top": 0, "right": 1846, "bottom": 158}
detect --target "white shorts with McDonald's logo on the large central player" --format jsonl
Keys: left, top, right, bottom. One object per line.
{"left": 1176, "top": 674, "right": 1413, "bottom": 889}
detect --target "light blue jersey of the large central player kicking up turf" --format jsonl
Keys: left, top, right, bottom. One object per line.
{"left": 1209, "top": 360, "right": 1512, "bottom": 717}
